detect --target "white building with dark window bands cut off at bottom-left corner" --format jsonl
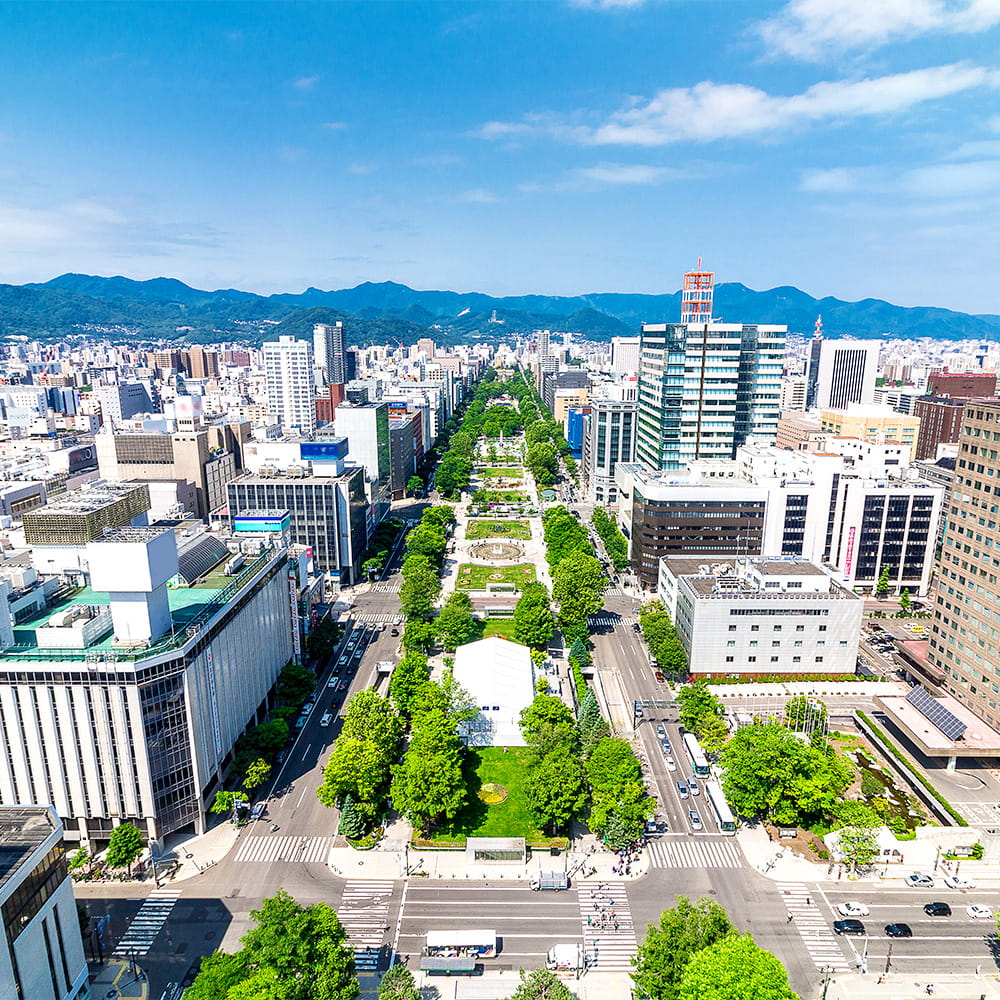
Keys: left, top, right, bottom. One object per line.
{"left": 0, "top": 805, "right": 89, "bottom": 1000}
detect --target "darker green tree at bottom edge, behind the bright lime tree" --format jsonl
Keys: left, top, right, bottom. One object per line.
{"left": 632, "top": 896, "right": 735, "bottom": 1000}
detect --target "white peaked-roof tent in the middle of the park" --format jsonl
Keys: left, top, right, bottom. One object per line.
{"left": 453, "top": 636, "right": 535, "bottom": 747}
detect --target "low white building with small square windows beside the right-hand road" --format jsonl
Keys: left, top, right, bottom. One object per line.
{"left": 658, "top": 557, "right": 864, "bottom": 677}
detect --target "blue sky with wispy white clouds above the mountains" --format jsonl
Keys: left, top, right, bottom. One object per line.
{"left": 0, "top": 0, "right": 1000, "bottom": 312}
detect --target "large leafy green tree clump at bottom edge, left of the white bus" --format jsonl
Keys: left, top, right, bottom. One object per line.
{"left": 185, "top": 890, "right": 359, "bottom": 1000}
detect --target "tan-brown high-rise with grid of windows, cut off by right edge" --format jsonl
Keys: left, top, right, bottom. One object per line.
{"left": 927, "top": 399, "right": 1000, "bottom": 730}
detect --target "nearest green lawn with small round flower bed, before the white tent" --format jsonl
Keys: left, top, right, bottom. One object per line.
{"left": 414, "top": 747, "right": 567, "bottom": 847}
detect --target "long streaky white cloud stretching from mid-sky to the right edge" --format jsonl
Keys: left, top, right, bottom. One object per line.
{"left": 476, "top": 63, "right": 1000, "bottom": 146}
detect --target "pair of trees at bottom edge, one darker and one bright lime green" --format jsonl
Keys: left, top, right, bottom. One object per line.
{"left": 632, "top": 896, "right": 797, "bottom": 1000}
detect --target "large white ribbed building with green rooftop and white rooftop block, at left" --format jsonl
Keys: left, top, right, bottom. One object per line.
{"left": 0, "top": 527, "right": 297, "bottom": 842}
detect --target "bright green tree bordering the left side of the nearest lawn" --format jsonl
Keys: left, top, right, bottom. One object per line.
{"left": 392, "top": 709, "right": 468, "bottom": 830}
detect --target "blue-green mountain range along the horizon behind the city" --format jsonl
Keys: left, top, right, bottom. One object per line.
{"left": 0, "top": 274, "right": 1000, "bottom": 344}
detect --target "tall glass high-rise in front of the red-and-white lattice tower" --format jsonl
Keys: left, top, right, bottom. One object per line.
{"left": 636, "top": 323, "right": 787, "bottom": 471}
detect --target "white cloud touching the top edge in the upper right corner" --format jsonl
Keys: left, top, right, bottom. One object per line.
{"left": 757, "top": 0, "right": 1000, "bottom": 60}
